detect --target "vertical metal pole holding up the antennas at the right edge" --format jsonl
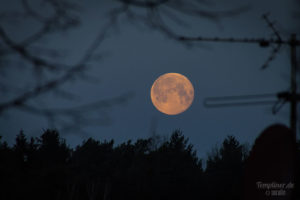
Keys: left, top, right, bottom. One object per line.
{"left": 290, "top": 34, "right": 297, "bottom": 139}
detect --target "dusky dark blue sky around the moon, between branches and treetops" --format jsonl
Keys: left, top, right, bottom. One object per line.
{"left": 0, "top": 0, "right": 297, "bottom": 157}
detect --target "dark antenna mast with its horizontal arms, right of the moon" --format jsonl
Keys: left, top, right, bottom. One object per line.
{"left": 178, "top": 14, "right": 300, "bottom": 139}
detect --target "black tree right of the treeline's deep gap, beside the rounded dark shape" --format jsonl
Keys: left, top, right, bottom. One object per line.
{"left": 205, "top": 136, "right": 247, "bottom": 200}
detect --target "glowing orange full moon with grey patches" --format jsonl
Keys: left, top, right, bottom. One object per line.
{"left": 151, "top": 73, "right": 194, "bottom": 115}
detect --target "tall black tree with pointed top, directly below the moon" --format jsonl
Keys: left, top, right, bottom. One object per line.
{"left": 146, "top": 130, "right": 202, "bottom": 199}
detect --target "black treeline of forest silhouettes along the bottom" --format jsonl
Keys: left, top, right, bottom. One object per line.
{"left": 0, "top": 130, "right": 298, "bottom": 200}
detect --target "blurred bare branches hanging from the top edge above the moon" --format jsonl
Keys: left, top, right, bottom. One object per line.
{"left": 112, "top": 0, "right": 250, "bottom": 40}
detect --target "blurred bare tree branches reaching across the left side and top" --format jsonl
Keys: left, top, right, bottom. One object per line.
{"left": 0, "top": 0, "right": 249, "bottom": 130}
